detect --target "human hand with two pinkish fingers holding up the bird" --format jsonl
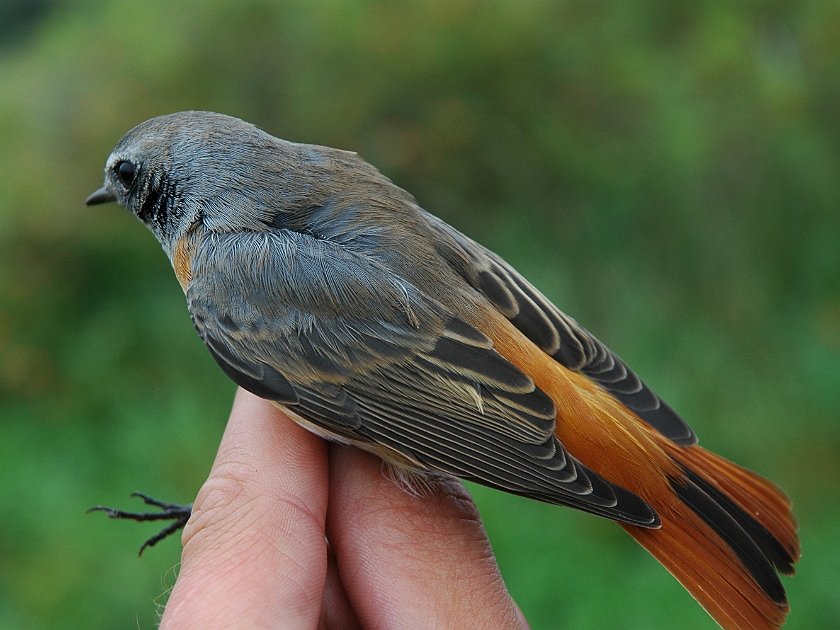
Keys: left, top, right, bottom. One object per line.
{"left": 160, "top": 389, "right": 528, "bottom": 630}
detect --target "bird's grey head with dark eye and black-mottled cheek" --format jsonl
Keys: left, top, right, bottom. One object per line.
{"left": 85, "top": 111, "right": 355, "bottom": 257}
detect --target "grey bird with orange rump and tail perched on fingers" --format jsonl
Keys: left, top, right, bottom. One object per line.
{"left": 86, "top": 111, "right": 800, "bottom": 630}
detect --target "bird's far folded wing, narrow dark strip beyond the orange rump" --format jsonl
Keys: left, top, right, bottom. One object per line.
{"left": 427, "top": 215, "right": 697, "bottom": 446}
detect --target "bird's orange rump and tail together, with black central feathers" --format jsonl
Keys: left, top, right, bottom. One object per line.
{"left": 480, "top": 321, "right": 800, "bottom": 630}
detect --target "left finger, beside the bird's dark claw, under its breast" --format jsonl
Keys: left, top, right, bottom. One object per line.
{"left": 160, "top": 389, "right": 328, "bottom": 630}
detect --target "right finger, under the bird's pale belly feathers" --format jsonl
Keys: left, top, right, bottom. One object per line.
{"left": 327, "top": 445, "right": 522, "bottom": 629}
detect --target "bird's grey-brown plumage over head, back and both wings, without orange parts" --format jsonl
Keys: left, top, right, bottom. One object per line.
{"left": 91, "top": 112, "right": 694, "bottom": 526}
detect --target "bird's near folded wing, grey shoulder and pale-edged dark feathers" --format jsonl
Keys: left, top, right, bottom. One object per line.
{"left": 187, "top": 230, "right": 658, "bottom": 527}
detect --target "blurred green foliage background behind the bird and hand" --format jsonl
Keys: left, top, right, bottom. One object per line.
{"left": 0, "top": 0, "right": 840, "bottom": 630}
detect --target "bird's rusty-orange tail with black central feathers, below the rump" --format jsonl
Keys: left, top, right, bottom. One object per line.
{"left": 622, "top": 440, "right": 800, "bottom": 630}
